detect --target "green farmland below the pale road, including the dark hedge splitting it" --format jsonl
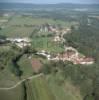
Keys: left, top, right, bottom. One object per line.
{"left": 0, "top": 75, "right": 55, "bottom": 100}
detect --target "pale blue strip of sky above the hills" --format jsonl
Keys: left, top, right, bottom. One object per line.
{"left": 0, "top": 0, "right": 99, "bottom": 4}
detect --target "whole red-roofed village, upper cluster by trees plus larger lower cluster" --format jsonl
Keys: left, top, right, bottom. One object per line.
{"left": 34, "top": 25, "right": 94, "bottom": 65}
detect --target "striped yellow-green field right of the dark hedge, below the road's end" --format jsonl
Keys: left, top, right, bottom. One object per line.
{"left": 26, "top": 75, "right": 55, "bottom": 100}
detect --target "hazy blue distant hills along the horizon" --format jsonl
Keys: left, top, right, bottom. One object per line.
{"left": 0, "top": 3, "right": 99, "bottom": 9}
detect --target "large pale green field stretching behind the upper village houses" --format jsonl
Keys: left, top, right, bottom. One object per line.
{"left": 0, "top": 15, "right": 75, "bottom": 37}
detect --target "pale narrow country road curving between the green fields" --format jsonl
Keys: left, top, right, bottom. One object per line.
{"left": 0, "top": 73, "right": 43, "bottom": 90}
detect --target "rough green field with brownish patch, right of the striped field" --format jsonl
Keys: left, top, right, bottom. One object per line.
{"left": 48, "top": 73, "right": 82, "bottom": 100}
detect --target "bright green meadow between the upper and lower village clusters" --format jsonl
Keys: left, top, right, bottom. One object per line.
{"left": 32, "top": 37, "right": 64, "bottom": 53}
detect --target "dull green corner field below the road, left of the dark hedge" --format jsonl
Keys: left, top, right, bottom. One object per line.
{"left": 0, "top": 85, "right": 24, "bottom": 100}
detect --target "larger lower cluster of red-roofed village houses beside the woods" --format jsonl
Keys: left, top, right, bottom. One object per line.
{"left": 37, "top": 47, "right": 94, "bottom": 65}
